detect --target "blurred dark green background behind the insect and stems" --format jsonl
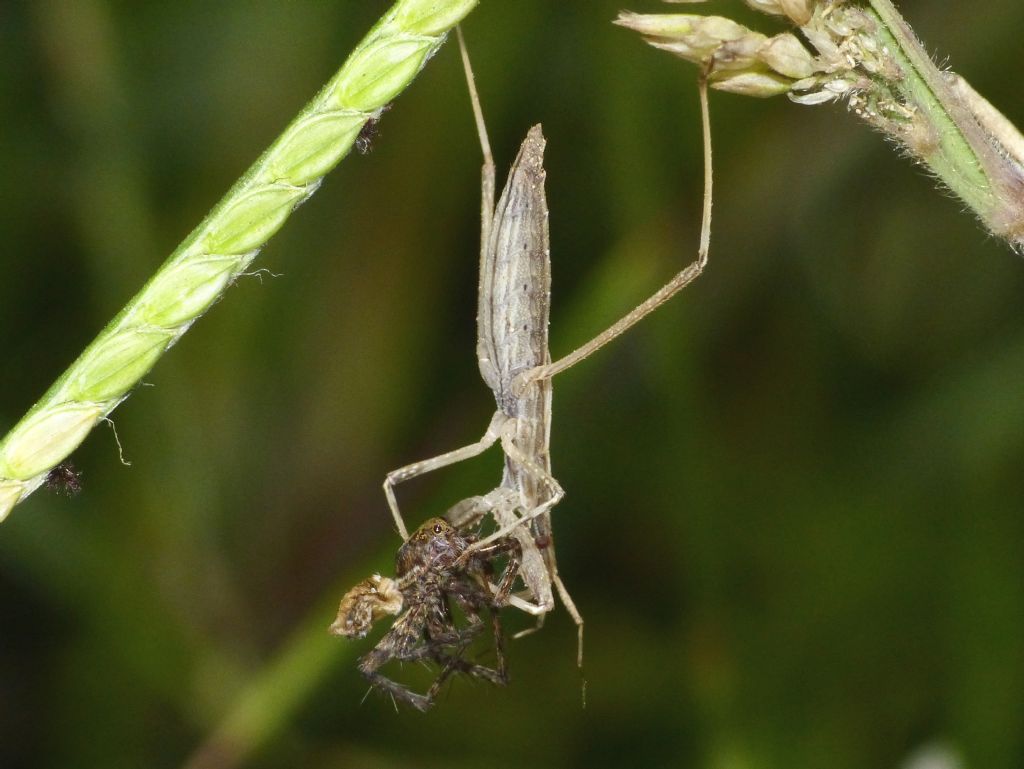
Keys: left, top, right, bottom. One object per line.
{"left": 0, "top": 0, "right": 1024, "bottom": 769}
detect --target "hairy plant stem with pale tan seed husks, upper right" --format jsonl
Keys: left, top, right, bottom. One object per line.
{"left": 617, "top": 0, "right": 1024, "bottom": 251}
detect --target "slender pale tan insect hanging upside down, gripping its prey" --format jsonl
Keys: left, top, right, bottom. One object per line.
{"left": 384, "top": 29, "right": 712, "bottom": 667}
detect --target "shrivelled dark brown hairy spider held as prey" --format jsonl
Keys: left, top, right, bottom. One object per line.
{"left": 330, "top": 518, "right": 521, "bottom": 711}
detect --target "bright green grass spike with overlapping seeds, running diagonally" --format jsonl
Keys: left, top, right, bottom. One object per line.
{"left": 0, "top": 0, "right": 479, "bottom": 520}
